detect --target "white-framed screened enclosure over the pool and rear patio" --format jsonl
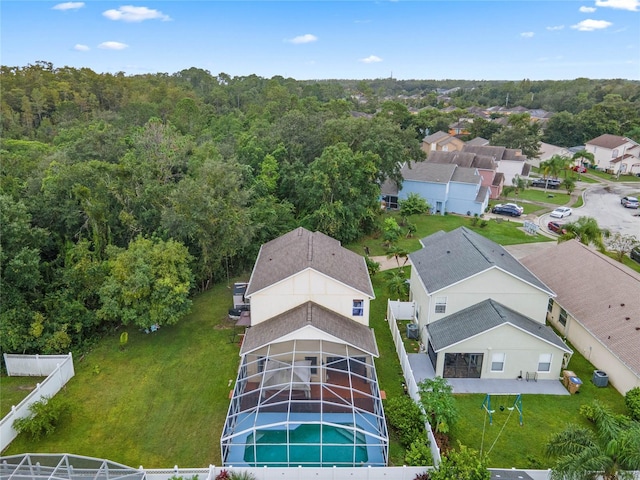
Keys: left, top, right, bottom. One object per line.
{"left": 221, "top": 339, "right": 389, "bottom": 467}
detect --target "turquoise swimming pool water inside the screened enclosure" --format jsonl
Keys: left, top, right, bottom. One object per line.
{"left": 244, "top": 424, "right": 368, "bottom": 467}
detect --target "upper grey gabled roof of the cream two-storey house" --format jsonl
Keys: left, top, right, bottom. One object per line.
{"left": 409, "top": 227, "right": 554, "bottom": 295}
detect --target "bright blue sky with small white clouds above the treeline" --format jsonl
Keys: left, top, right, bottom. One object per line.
{"left": 0, "top": 0, "right": 640, "bottom": 80}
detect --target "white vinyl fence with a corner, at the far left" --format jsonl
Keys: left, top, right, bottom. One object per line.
{"left": 0, "top": 353, "right": 75, "bottom": 451}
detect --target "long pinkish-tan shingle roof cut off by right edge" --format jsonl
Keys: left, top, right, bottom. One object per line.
{"left": 522, "top": 240, "right": 640, "bottom": 375}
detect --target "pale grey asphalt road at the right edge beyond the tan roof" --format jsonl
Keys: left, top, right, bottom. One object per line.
{"left": 540, "top": 183, "right": 640, "bottom": 238}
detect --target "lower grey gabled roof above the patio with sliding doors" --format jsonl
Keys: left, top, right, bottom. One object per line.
{"left": 427, "top": 299, "right": 573, "bottom": 353}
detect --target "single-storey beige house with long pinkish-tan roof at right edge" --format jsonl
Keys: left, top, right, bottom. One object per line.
{"left": 522, "top": 240, "right": 640, "bottom": 395}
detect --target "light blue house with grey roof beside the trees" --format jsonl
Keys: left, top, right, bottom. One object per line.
{"left": 381, "top": 161, "right": 490, "bottom": 215}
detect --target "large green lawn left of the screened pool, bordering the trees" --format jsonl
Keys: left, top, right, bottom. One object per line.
{"left": 2, "top": 285, "right": 239, "bottom": 468}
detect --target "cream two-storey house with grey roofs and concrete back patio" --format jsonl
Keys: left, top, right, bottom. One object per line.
{"left": 409, "top": 227, "right": 572, "bottom": 380}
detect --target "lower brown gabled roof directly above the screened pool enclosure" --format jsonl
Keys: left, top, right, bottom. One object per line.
{"left": 240, "top": 302, "right": 378, "bottom": 357}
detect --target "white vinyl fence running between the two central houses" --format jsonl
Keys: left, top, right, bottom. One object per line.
{"left": 387, "top": 300, "right": 441, "bottom": 466}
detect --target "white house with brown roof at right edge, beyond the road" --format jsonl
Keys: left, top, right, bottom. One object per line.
{"left": 585, "top": 133, "right": 640, "bottom": 175}
